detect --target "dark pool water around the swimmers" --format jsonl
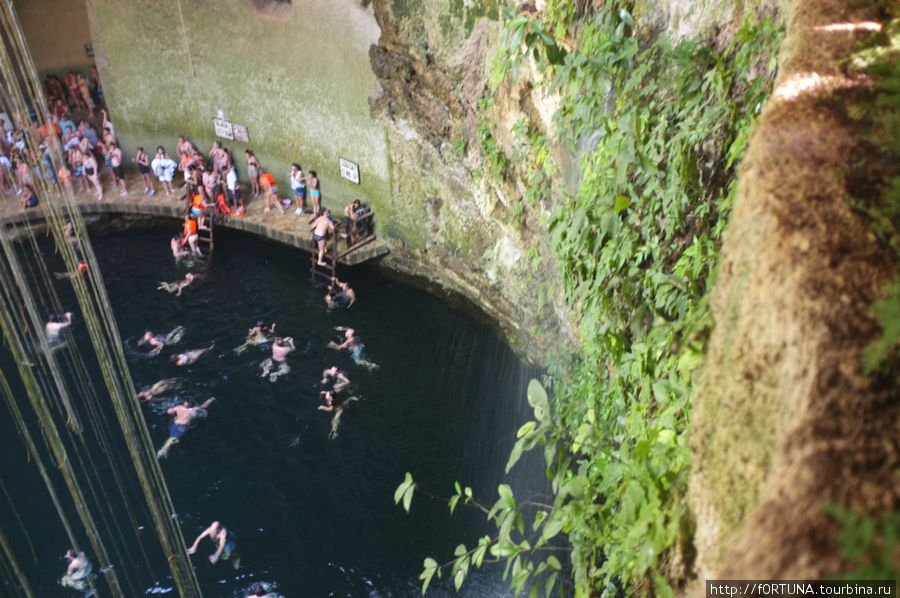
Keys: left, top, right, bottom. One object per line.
{"left": 0, "top": 223, "right": 541, "bottom": 597}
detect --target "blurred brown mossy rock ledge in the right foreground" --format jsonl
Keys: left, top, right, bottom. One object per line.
{"left": 689, "top": 0, "right": 900, "bottom": 579}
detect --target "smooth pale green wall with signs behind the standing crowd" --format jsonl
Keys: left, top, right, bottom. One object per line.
{"left": 89, "top": 0, "right": 390, "bottom": 216}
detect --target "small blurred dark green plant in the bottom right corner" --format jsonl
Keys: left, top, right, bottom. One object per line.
{"left": 824, "top": 504, "right": 900, "bottom": 580}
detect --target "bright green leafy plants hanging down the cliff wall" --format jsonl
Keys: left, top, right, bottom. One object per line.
{"left": 398, "top": 0, "right": 782, "bottom": 596}
